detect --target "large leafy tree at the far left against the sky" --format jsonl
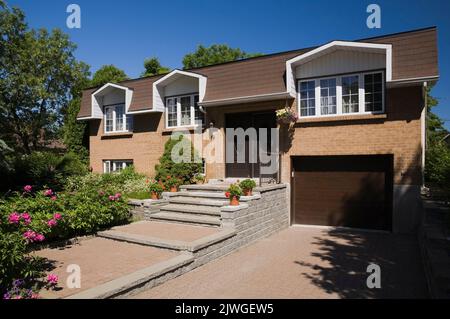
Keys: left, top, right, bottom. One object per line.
{"left": 0, "top": 2, "right": 89, "bottom": 154}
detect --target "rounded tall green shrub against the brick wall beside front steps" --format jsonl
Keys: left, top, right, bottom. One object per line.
{"left": 155, "top": 135, "right": 202, "bottom": 184}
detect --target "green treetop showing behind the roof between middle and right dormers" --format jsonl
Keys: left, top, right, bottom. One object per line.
{"left": 183, "top": 44, "right": 262, "bottom": 69}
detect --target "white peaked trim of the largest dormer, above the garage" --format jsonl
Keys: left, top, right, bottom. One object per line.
{"left": 286, "top": 41, "right": 392, "bottom": 93}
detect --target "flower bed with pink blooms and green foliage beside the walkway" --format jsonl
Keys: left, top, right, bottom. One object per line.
{"left": 0, "top": 185, "right": 130, "bottom": 299}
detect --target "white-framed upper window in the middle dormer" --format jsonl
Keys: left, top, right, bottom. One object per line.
{"left": 166, "top": 94, "right": 204, "bottom": 127}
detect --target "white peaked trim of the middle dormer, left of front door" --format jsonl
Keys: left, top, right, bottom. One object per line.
{"left": 153, "top": 70, "right": 207, "bottom": 112}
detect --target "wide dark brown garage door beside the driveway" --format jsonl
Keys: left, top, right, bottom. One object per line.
{"left": 293, "top": 155, "right": 393, "bottom": 230}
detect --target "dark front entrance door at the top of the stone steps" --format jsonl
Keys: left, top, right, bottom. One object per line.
{"left": 225, "top": 111, "right": 277, "bottom": 178}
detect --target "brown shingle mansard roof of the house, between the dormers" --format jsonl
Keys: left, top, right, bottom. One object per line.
{"left": 78, "top": 27, "right": 439, "bottom": 118}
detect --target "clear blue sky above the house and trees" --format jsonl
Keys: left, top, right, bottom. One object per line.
{"left": 8, "top": 0, "right": 450, "bottom": 129}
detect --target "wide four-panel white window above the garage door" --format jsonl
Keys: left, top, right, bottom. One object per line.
{"left": 298, "top": 72, "right": 384, "bottom": 117}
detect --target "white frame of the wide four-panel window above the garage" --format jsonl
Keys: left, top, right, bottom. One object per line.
{"left": 297, "top": 70, "right": 386, "bottom": 118}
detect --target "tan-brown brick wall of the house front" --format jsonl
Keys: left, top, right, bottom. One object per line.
{"left": 90, "top": 86, "right": 424, "bottom": 190}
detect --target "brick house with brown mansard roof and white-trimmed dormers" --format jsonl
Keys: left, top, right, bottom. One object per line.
{"left": 78, "top": 28, "right": 439, "bottom": 232}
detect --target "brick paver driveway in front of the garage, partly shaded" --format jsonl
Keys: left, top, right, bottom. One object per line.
{"left": 134, "top": 227, "right": 427, "bottom": 298}
